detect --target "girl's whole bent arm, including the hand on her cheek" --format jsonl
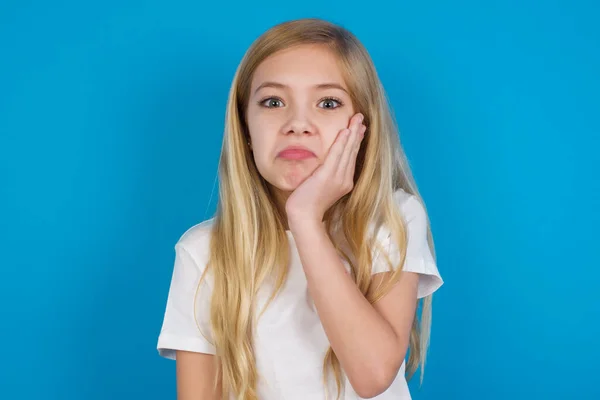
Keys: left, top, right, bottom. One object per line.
{"left": 285, "top": 113, "right": 419, "bottom": 397}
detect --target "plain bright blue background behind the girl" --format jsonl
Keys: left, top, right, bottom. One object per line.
{"left": 0, "top": 0, "right": 600, "bottom": 400}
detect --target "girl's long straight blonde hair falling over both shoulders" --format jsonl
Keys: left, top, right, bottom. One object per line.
{"left": 196, "top": 18, "right": 435, "bottom": 400}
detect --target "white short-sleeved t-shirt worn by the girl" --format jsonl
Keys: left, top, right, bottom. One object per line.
{"left": 157, "top": 189, "right": 443, "bottom": 400}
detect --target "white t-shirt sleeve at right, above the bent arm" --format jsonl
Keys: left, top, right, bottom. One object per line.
{"left": 373, "top": 195, "right": 443, "bottom": 299}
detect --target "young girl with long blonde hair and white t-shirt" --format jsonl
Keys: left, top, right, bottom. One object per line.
{"left": 158, "top": 19, "right": 442, "bottom": 400}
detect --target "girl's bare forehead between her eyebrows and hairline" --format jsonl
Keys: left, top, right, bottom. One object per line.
{"left": 252, "top": 45, "right": 346, "bottom": 88}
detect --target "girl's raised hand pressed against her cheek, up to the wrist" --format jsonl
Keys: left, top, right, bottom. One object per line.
{"left": 285, "top": 113, "right": 367, "bottom": 228}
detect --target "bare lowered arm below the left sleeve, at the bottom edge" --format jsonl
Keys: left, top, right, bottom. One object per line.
{"left": 176, "top": 350, "right": 221, "bottom": 400}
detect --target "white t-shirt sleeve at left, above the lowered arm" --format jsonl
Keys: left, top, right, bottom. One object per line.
{"left": 157, "top": 243, "right": 215, "bottom": 360}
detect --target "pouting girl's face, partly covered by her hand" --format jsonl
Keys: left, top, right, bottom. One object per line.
{"left": 246, "top": 45, "right": 354, "bottom": 192}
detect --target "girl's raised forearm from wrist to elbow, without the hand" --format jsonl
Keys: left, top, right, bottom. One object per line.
{"left": 290, "top": 222, "right": 404, "bottom": 390}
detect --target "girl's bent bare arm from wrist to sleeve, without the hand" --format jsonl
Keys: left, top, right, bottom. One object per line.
{"left": 290, "top": 220, "right": 418, "bottom": 398}
